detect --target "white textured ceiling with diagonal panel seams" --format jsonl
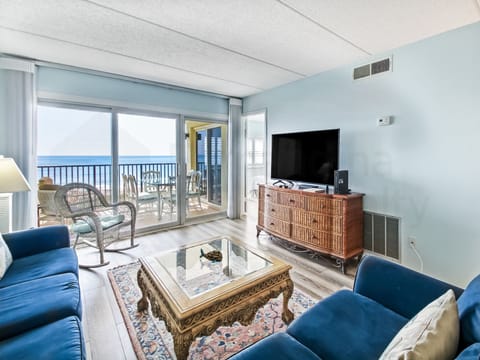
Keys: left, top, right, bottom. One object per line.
{"left": 0, "top": 0, "right": 480, "bottom": 97}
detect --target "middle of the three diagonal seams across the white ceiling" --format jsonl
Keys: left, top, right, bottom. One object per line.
{"left": 82, "top": 0, "right": 307, "bottom": 77}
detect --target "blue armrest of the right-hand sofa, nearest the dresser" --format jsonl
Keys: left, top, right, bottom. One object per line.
{"left": 353, "top": 256, "right": 463, "bottom": 319}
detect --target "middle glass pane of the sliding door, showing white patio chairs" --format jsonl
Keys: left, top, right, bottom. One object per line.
{"left": 117, "top": 113, "right": 179, "bottom": 228}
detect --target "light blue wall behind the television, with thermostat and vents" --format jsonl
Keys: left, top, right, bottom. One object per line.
{"left": 244, "top": 23, "right": 480, "bottom": 285}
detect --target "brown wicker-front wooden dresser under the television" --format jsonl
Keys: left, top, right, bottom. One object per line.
{"left": 257, "top": 185, "right": 363, "bottom": 272}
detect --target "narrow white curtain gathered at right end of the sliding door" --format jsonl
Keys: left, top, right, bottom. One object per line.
{"left": 227, "top": 99, "right": 242, "bottom": 219}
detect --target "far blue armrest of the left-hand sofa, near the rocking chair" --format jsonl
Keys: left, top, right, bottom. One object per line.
{"left": 2, "top": 225, "right": 70, "bottom": 259}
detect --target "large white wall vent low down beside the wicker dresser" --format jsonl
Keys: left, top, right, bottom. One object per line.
{"left": 363, "top": 211, "right": 400, "bottom": 260}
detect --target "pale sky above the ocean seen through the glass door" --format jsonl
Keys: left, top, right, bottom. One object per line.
{"left": 37, "top": 105, "right": 176, "bottom": 156}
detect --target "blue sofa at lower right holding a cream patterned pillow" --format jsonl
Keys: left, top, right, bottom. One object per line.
{"left": 230, "top": 256, "right": 480, "bottom": 360}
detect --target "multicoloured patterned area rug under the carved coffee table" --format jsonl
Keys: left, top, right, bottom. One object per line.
{"left": 108, "top": 263, "right": 317, "bottom": 360}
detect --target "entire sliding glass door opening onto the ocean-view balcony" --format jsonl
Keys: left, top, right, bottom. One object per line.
{"left": 37, "top": 104, "right": 227, "bottom": 230}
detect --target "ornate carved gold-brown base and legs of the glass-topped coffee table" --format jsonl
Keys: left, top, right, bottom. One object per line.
{"left": 137, "top": 250, "right": 293, "bottom": 360}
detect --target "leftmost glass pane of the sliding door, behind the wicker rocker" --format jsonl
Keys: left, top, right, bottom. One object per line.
{"left": 37, "top": 105, "right": 112, "bottom": 198}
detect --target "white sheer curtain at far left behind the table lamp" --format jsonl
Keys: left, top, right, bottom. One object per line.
{"left": 0, "top": 57, "right": 37, "bottom": 230}
